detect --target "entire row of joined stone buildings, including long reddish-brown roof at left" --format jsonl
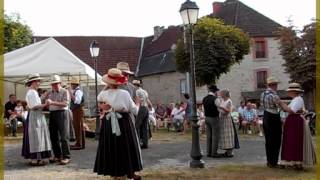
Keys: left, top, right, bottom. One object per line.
{"left": 35, "top": 0, "right": 289, "bottom": 112}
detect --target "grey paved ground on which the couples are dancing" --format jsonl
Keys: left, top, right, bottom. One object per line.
{"left": 5, "top": 134, "right": 266, "bottom": 179}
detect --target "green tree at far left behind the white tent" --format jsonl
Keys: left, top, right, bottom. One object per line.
{"left": 4, "top": 14, "right": 33, "bottom": 53}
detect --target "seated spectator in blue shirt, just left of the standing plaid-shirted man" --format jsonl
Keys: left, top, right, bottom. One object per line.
{"left": 242, "top": 102, "right": 257, "bottom": 134}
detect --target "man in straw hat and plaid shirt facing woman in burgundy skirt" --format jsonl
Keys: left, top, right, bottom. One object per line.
{"left": 260, "top": 77, "right": 282, "bottom": 168}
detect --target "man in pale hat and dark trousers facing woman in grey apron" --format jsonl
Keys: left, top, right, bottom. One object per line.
{"left": 47, "top": 75, "right": 70, "bottom": 165}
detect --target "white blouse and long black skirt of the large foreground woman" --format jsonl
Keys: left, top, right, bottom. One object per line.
{"left": 94, "top": 89, "right": 142, "bottom": 176}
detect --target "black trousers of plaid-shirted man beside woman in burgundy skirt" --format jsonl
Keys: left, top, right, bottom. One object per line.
{"left": 263, "top": 111, "right": 282, "bottom": 165}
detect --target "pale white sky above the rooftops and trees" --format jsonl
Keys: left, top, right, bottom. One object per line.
{"left": 4, "top": 0, "right": 316, "bottom": 37}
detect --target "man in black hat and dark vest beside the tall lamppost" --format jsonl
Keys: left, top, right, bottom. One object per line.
{"left": 202, "top": 85, "right": 222, "bottom": 158}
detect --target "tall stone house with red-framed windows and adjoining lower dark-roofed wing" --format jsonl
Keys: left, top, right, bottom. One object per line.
{"left": 137, "top": 0, "right": 289, "bottom": 105}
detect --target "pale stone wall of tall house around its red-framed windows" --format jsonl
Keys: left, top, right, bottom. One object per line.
{"left": 217, "top": 38, "right": 290, "bottom": 106}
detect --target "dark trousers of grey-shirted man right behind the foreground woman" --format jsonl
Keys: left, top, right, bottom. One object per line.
{"left": 135, "top": 106, "right": 149, "bottom": 147}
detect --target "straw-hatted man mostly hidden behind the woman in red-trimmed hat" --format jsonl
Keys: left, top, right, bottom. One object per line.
{"left": 117, "top": 62, "right": 137, "bottom": 101}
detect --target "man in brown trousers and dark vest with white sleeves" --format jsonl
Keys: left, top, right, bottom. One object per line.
{"left": 69, "top": 77, "right": 85, "bottom": 150}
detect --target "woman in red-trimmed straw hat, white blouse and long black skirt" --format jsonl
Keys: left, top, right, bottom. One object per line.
{"left": 94, "top": 68, "right": 142, "bottom": 179}
